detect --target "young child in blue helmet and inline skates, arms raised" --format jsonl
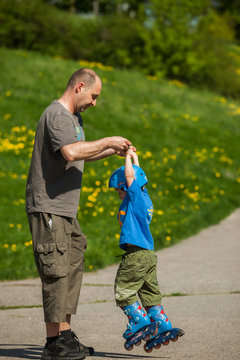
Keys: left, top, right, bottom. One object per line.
{"left": 109, "top": 147, "right": 184, "bottom": 352}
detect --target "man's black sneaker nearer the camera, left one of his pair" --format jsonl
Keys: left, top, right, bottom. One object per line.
{"left": 41, "top": 335, "right": 86, "bottom": 360}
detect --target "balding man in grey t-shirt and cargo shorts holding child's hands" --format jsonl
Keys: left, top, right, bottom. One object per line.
{"left": 26, "top": 69, "right": 131, "bottom": 360}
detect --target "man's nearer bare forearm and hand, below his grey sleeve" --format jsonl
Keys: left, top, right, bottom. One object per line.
{"left": 60, "top": 136, "right": 131, "bottom": 161}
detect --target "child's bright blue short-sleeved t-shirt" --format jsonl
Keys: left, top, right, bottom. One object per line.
{"left": 118, "top": 179, "right": 154, "bottom": 250}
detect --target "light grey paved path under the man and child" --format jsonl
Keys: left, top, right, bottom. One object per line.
{"left": 0, "top": 209, "right": 240, "bottom": 360}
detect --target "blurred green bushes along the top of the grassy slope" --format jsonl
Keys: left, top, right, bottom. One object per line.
{"left": 0, "top": 0, "right": 240, "bottom": 97}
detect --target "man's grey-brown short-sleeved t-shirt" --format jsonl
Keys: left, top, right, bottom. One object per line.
{"left": 26, "top": 100, "right": 85, "bottom": 218}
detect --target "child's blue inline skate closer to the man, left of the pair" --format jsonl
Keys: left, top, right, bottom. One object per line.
{"left": 122, "top": 301, "right": 157, "bottom": 351}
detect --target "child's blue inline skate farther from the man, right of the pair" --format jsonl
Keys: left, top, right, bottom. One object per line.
{"left": 144, "top": 305, "right": 184, "bottom": 353}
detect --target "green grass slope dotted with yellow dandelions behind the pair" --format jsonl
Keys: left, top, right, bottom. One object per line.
{"left": 0, "top": 49, "right": 240, "bottom": 279}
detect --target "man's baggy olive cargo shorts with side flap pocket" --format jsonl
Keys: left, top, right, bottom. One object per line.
{"left": 28, "top": 212, "right": 87, "bottom": 322}
